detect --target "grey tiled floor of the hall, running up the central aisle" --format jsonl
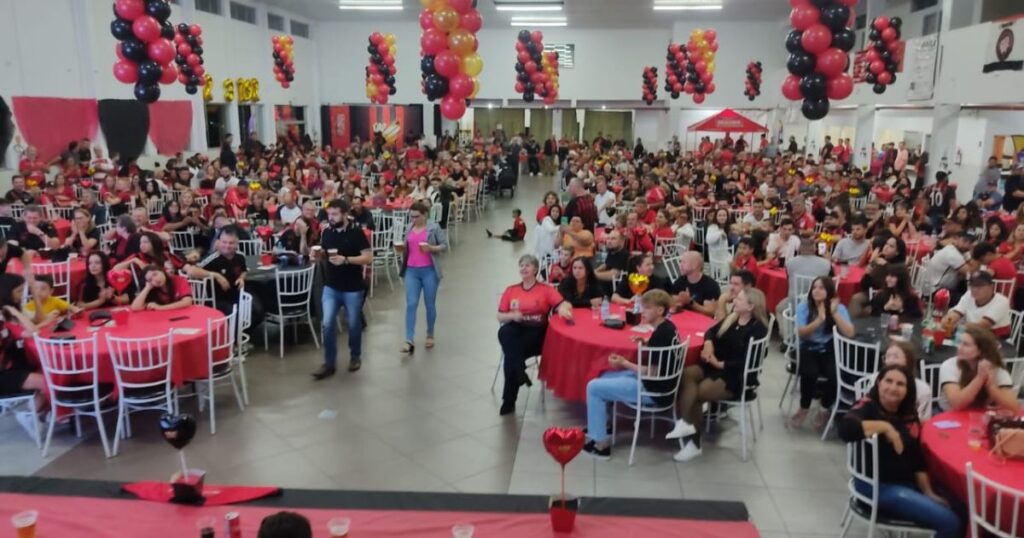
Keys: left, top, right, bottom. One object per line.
{"left": 0, "top": 177, "right": 872, "bottom": 537}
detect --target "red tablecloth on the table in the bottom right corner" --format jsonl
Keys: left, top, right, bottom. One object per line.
{"left": 921, "top": 411, "right": 1024, "bottom": 536}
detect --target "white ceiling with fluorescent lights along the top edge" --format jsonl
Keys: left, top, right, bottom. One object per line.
{"left": 259, "top": 0, "right": 790, "bottom": 29}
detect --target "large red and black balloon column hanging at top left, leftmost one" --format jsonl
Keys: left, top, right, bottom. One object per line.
{"left": 111, "top": 0, "right": 178, "bottom": 102}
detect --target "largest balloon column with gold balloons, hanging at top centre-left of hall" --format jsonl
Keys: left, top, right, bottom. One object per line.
{"left": 420, "top": 0, "right": 483, "bottom": 120}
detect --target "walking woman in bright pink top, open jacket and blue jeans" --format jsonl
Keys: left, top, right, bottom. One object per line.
{"left": 401, "top": 202, "right": 447, "bottom": 355}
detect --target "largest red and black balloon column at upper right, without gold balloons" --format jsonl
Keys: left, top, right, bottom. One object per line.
{"left": 782, "top": 0, "right": 857, "bottom": 120}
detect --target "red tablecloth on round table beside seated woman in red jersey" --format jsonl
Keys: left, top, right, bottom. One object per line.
{"left": 540, "top": 306, "right": 715, "bottom": 402}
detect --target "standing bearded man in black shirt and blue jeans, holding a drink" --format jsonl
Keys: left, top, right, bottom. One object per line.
{"left": 312, "top": 200, "right": 374, "bottom": 381}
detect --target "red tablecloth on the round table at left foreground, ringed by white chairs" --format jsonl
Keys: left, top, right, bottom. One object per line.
{"left": 26, "top": 306, "right": 224, "bottom": 386}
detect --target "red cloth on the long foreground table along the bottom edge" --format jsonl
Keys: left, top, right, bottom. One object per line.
{"left": 0, "top": 489, "right": 758, "bottom": 538}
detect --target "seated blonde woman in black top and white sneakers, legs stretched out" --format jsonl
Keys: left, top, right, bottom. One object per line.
{"left": 665, "top": 288, "right": 769, "bottom": 461}
